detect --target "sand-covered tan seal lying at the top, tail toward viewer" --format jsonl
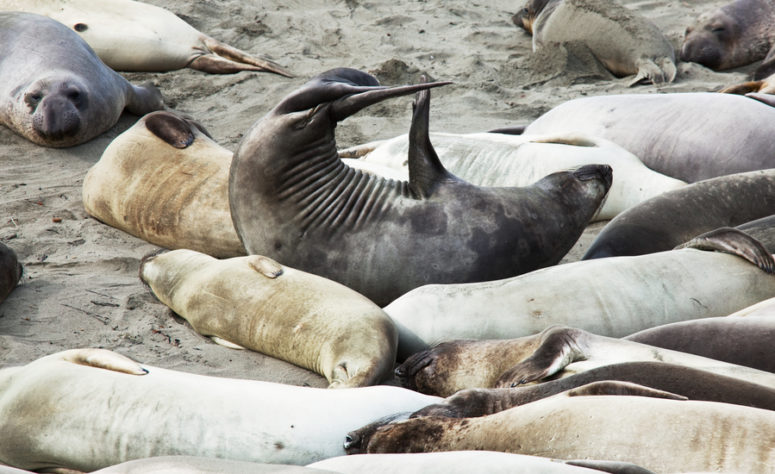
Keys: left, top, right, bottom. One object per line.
{"left": 512, "top": 0, "right": 677, "bottom": 86}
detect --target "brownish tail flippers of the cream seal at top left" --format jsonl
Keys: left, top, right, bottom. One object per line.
{"left": 188, "top": 36, "right": 293, "bottom": 77}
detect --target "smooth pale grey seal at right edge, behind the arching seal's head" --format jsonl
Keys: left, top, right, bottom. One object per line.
{"left": 525, "top": 92, "right": 775, "bottom": 182}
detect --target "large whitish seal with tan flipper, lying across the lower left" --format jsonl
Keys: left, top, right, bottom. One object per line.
{"left": 0, "top": 349, "right": 440, "bottom": 472}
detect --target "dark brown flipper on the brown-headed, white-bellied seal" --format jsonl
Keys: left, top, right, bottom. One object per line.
{"left": 495, "top": 326, "right": 586, "bottom": 388}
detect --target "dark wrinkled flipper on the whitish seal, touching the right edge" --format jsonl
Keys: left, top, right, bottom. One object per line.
{"left": 675, "top": 227, "right": 775, "bottom": 273}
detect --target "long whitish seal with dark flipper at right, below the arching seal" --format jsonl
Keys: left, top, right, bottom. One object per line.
{"left": 384, "top": 230, "right": 775, "bottom": 360}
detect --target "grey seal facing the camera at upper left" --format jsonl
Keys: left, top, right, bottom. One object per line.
{"left": 0, "top": 12, "right": 164, "bottom": 147}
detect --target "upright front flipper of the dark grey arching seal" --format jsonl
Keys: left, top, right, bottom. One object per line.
{"left": 409, "top": 82, "right": 457, "bottom": 198}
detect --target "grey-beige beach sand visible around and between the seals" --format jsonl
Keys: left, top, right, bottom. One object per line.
{"left": 0, "top": 0, "right": 753, "bottom": 386}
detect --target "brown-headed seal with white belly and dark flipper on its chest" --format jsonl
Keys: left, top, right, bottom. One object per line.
{"left": 396, "top": 326, "right": 775, "bottom": 396}
